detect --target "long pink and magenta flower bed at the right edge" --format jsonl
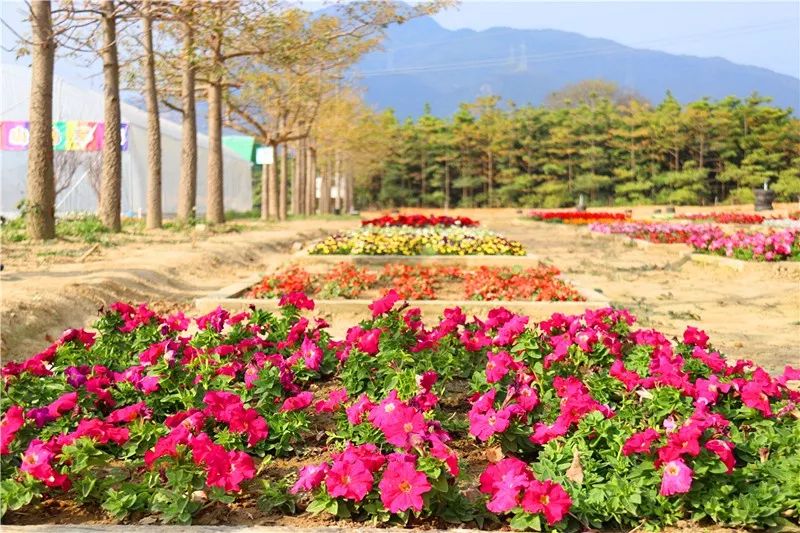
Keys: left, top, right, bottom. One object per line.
{"left": 589, "top": 222, "right": 800, "bottom": 262}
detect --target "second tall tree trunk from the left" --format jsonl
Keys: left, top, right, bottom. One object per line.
{"left": 99, "top": 0, "right": 122, "bottom": 232}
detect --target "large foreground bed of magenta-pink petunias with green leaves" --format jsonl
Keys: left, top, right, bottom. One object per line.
{"left": 0, "top": 300, "right": 800, "bottom": 530}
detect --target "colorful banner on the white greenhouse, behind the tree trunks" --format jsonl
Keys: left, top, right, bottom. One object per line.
{"left": 0, "top": 120, "right": 130, "bottom": 152}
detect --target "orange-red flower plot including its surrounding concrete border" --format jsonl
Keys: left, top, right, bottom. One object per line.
{"left": 195, "top": 263, "right": 610, "bottom": 322}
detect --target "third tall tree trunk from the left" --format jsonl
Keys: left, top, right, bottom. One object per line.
{"left": 142, "top": 0, "right": 162, "bottom": 229}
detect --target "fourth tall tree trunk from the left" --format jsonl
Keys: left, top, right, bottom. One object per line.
{"left": 178, "top": 23, "right": 197, "bottom": 223}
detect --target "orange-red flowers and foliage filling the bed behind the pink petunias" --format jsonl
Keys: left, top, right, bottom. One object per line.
{"left": 245, "top": 263, "right": 584, "bottom": 301}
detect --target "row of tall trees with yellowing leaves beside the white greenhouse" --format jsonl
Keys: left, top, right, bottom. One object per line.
{"left": 20, "top": 0, "right": 443, "bottom": 239}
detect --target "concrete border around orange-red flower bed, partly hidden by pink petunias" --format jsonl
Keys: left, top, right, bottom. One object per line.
{"left": 195, "top": 274, "right": 611, "bottom": 319}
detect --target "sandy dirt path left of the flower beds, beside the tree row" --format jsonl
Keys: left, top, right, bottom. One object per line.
{"left": 0, "top": 220, "right": 355, "bottom": 360}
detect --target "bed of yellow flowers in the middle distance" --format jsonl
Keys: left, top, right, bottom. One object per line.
{"left": 308, "top": 226, "right": 525, "bottom": 256}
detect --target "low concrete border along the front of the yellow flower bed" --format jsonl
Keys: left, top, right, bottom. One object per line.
{"left": 291, "top": 250, "right": 539, "bottom": 267}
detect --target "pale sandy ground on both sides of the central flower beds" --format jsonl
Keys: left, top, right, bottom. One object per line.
{"left": 0, "top": 205, "right": 800, "bottom": 370}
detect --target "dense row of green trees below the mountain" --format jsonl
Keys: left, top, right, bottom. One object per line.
{"left": 359, "top": 85, "right": 800, "bottom": 207}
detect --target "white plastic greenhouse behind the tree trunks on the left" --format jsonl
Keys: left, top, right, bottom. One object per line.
{"left": 0, "top": 64, "right": 252, "bottom": 216}
